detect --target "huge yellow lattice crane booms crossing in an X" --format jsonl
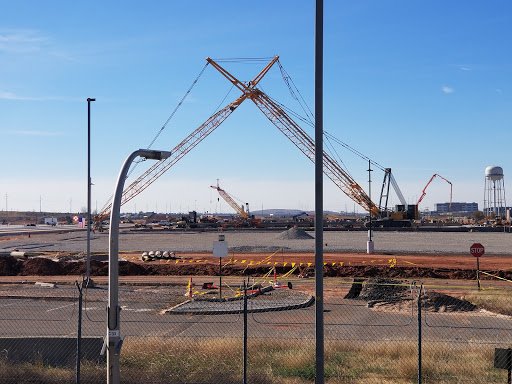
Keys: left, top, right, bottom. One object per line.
{"left": 96, "top": 56, "right": 404, "bottom": 223}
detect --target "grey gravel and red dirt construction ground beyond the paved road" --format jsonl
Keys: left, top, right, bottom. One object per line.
{"left": 0, "top": 228, "right": 512, "bottom": 283}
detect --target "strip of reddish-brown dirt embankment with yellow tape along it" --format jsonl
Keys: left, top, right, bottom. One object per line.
{"left": 0, "top": 254, "right": 512, "bottom": 280}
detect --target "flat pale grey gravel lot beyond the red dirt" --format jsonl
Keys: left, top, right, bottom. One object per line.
{"left": 0, "top": 229, "right": 512, "bottom": 255}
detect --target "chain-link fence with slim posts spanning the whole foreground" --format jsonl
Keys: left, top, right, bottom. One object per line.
{"left": 0, "top": 268, "right": 512, "bottom": 384}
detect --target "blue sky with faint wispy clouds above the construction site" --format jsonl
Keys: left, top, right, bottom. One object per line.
{"left": 0, "top": 0, "right": 512, "bottom": 216}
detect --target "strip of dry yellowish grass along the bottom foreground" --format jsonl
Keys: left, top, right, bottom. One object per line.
{"left": 0, "top": 338, "right": 506, "bottom": 384}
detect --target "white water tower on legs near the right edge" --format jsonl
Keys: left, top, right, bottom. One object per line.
{"left": 484, "top": 165, "right": 507, "bottom": 218}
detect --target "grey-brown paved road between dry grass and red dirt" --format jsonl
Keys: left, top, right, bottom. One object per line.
{"left": 0, "top": 280, "right": 512, "bottom": 345}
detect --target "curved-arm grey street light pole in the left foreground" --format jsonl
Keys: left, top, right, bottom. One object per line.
{"left": 106, "top": 149, "right": 171, "bottom": 384}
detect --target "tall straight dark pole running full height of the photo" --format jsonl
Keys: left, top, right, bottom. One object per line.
{"left": 315, "top": 0, "right": 325, "bottom": 384}
